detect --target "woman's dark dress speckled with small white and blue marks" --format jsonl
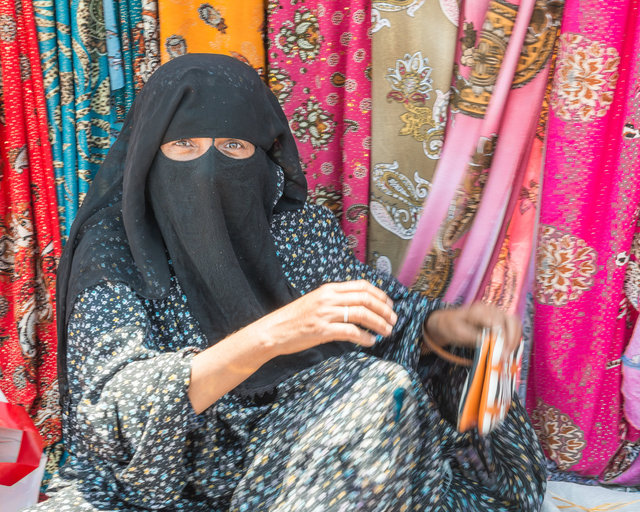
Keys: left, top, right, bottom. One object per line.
{"left": 36, "top": 206, "right": 546, "bottom": 512}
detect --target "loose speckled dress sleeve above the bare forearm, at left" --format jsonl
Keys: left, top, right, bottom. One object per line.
{"left": 65, "top": 283, "right": 204, "bottom": 509}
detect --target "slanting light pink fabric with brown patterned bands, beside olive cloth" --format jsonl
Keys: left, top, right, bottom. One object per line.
{"left": 399, "top": 0, "right": 563, "bottom": 311}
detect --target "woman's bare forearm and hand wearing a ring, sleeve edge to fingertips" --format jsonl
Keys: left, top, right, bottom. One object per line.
{"left": 188, "top": 281, "right": 397, "bottom": 414}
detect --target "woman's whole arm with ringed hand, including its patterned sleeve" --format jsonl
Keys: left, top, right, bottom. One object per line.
{"left": 65, "top": 281, "right": 394, "bottom": 508}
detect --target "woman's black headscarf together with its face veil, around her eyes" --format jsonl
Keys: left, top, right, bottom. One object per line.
{"left": 57, "top": 54, "right": 332, "bottom": 406}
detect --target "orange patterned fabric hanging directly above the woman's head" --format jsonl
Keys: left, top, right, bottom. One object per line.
{"left": 158, "top": 0, "right": 265, "bottom": 76}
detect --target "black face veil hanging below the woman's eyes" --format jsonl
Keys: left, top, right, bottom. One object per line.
{"left": 148, "top": 146, "right": 298, "bottom": 344}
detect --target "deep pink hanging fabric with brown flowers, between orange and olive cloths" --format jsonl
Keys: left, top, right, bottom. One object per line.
{"left": 267, "top": 0, "right": 371, "bottom": 260}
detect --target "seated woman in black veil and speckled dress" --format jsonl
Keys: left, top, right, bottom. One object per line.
{"left": 37, "top": 54, "right": 545, "bottom": 512}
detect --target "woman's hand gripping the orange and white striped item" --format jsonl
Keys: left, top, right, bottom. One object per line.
{"left": 426, "top": 302, "right": 522, "bottom": 358}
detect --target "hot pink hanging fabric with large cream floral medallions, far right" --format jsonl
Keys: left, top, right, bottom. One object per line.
{"left": 527, "top": 0, "right": 640, "bottom": 485}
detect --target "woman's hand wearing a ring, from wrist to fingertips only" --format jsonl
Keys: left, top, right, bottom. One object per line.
{"left": 247, "top": 280, "right": 397, "bottom": 357}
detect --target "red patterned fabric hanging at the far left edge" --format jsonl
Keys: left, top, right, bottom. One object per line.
{"left": 0, "top": 0, "right": 61, "bottom": 446}
